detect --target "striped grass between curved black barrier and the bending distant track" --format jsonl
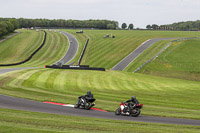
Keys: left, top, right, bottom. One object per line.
{"left": 20, "top": 31, "right": 69, "bottom": 67}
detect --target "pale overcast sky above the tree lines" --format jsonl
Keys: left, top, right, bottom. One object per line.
{"left": 0, "top": 0, "right": 200, "bottom": 28}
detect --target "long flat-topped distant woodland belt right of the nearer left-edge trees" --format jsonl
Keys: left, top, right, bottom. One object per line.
{"left": 17, "top": 18, "right": 118, "bottom": 29}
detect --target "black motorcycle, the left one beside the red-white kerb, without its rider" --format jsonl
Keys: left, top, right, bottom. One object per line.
{"left": 74, "top": 97, "right": 96, "bottom": 110}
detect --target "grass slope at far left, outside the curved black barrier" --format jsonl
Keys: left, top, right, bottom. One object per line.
{"left": 0, "top": 30, "right": 44, "bottom": 64}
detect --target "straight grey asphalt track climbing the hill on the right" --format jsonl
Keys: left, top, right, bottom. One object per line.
{"left": 111, "top": 38, "right": 177, "bottom": 71}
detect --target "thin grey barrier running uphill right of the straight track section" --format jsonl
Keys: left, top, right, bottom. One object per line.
{"left": 134, "top": 37, "right": 200, "bottom": 73}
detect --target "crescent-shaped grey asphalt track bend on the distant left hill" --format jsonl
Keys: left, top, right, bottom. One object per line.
{"left": 58, "top": 31, "right": 79, "bottom": 64}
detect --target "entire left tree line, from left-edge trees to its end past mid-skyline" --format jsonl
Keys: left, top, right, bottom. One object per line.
{"left": 0, "top": 18, "right": 118, "bottom": 36}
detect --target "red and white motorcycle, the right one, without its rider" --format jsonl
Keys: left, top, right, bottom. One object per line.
{"left": 115, "top": 102, "right": 143, "bottom": 117}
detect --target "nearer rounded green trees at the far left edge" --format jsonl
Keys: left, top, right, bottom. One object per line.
{"left": 0, "top": 18, "right": 19, "bottom": 36}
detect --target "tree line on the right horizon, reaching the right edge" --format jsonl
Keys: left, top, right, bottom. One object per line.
{"left": 146, "top": 20, "right": 200, "bottom": 31}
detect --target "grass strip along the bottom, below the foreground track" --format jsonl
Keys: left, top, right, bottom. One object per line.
{"left": 0, "top": 109, "right": 200, "bottom": 133}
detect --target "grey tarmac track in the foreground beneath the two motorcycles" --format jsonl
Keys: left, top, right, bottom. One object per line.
{"left": 0, "top": 95, "right": 200, "bottom": 126}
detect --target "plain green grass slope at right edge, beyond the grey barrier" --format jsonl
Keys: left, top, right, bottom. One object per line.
{"left": 140, "top": 40, "right": 200, "bottom": 81}
